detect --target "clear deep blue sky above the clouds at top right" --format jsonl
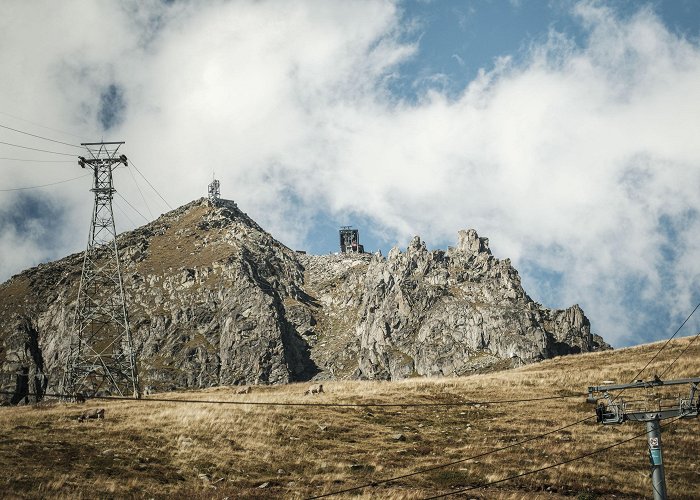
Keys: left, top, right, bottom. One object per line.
{"left": 403, "top": 0, "right": 700, "bottom": 88}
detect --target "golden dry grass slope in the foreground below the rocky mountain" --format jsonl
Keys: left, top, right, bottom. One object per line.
{"left": 0, "top": 338, "right": 700, "bottom": 500}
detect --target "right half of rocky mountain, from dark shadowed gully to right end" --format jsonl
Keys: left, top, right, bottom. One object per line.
{"left": 295, "top": 230, "right": 609, "bottom": 379}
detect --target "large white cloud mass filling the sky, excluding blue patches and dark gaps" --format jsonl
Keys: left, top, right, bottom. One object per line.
{"left": 0, "top": 1, "right": 700, "bottom": 342}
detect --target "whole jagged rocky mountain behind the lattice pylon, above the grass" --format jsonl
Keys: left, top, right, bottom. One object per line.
{"left": 0, "top": 199, "right": 609, "bottom": 403}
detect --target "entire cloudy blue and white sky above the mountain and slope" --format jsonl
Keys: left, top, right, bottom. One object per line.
{"left": 0, "top": 0, "right": 700, "bottom": 347}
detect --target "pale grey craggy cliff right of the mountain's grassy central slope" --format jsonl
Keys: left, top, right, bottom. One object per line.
{"left": 357, "top": 230, "right": 609, "bottom": 379}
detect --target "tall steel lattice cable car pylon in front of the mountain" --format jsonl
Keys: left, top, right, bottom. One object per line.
{"left": 63, "top": 142, "right": 140, "bottom": 397}
